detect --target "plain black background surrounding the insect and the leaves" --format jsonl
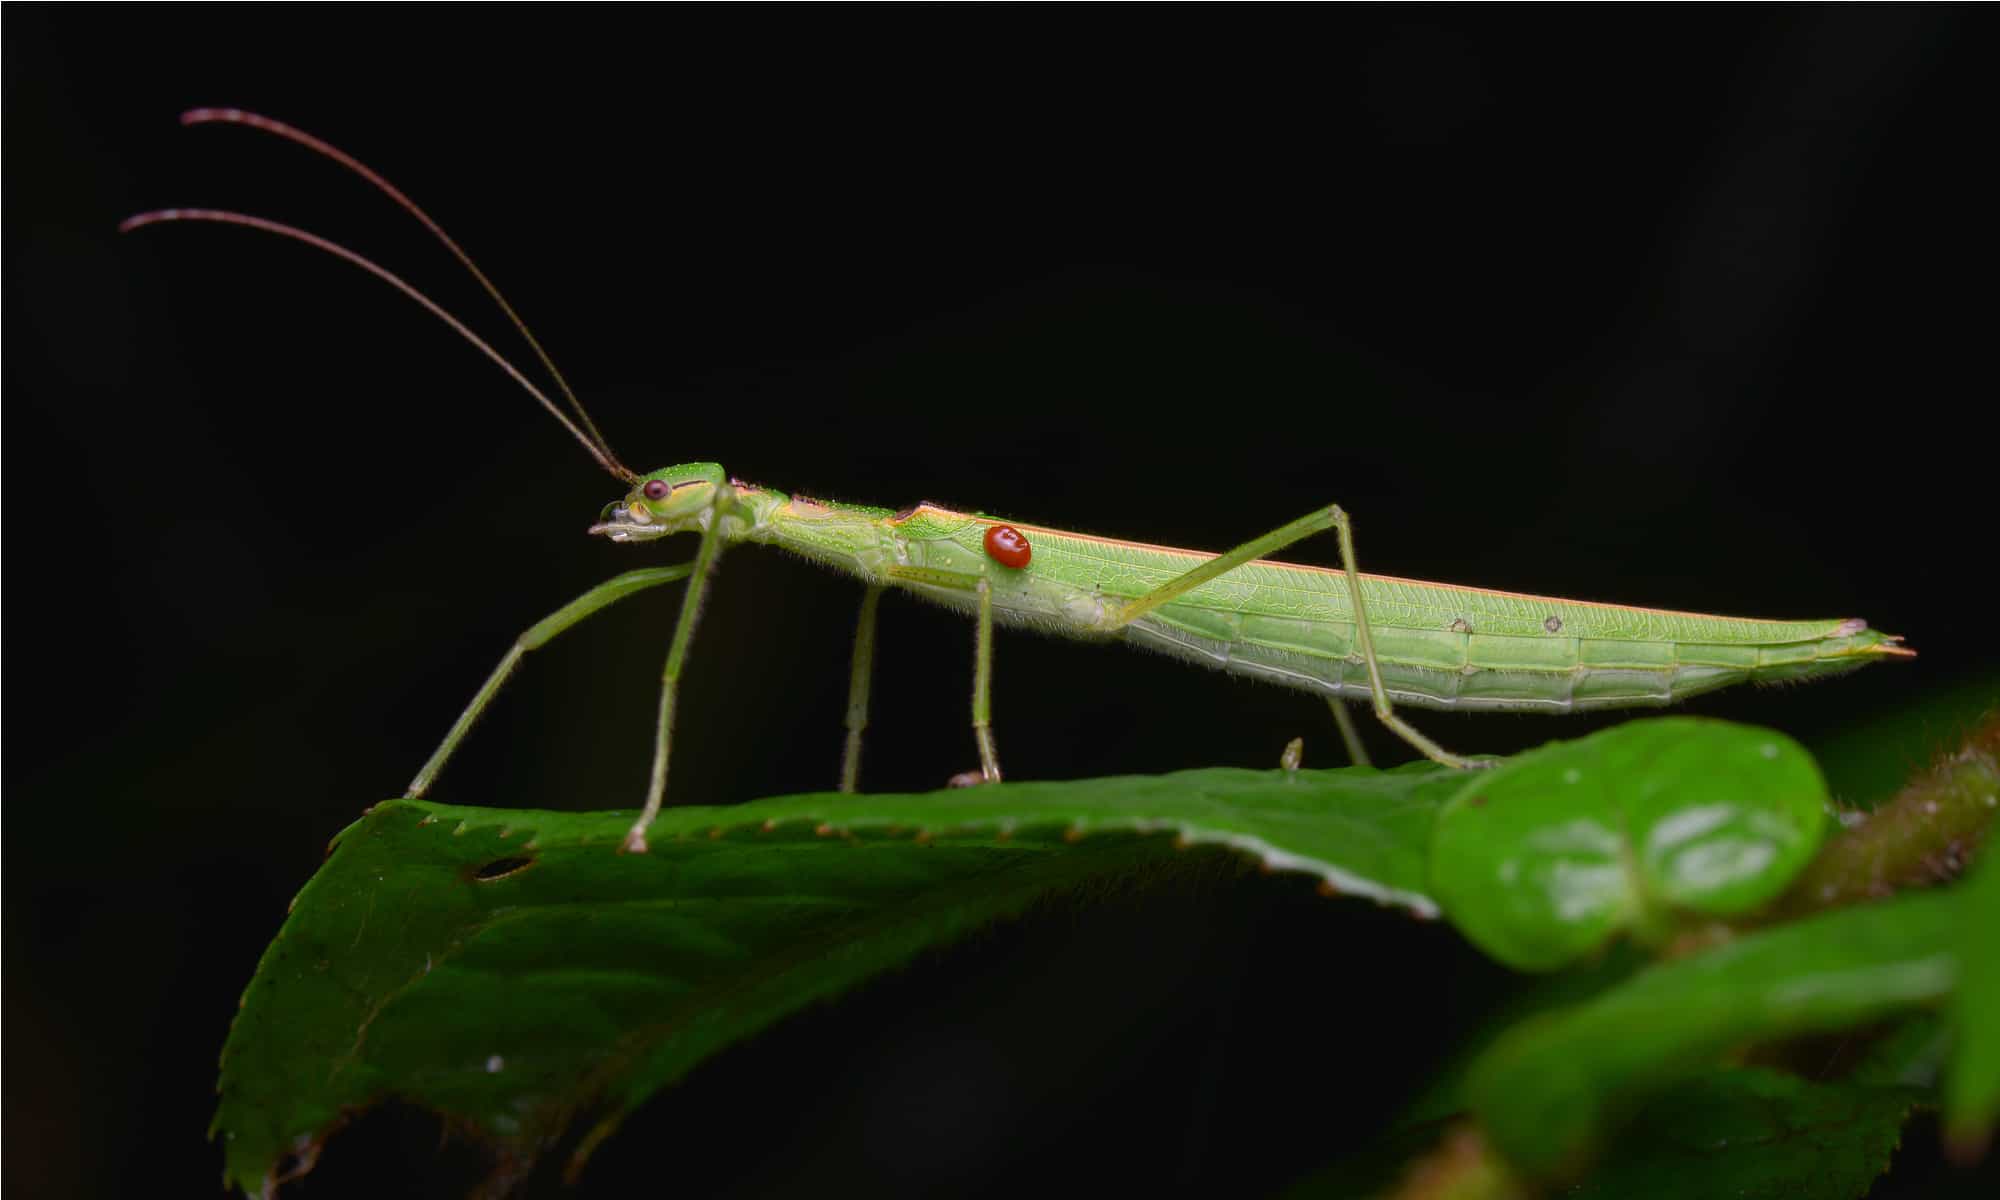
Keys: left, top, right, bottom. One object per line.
{"left": 4, "top": 8, "right": 1996, "bottom": 1196}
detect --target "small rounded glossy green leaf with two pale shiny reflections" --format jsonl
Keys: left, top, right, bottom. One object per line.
{"left": 1430, "top": 718, "right": 1826, "bottom": 970}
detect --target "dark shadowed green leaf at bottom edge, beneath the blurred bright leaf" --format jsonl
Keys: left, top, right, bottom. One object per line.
{"left": 1564, "top": 1068, "right": 1922, "bottom": 1200}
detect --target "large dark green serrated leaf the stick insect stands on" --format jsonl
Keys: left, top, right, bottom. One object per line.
{"left": 214, "top": 764, "right": 1462, "bottom": 1192}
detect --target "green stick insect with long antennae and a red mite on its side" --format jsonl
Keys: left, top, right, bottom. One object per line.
{"left": 120, "top": 108, "right": 1914, "bottom": 852}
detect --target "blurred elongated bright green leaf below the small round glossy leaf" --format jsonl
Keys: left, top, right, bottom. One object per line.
{"left": 1468, "top": 892, "right": 1966, "bottom": 1176}
